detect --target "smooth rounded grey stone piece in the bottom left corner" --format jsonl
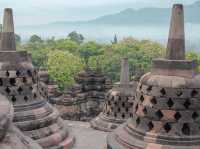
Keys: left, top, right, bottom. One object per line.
{"left": 0, "top": 94, "right": 42, "bottom": 149}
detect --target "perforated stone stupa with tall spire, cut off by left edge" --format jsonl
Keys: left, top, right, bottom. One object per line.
{"left": 0, "top": 8, "right": 74, "bottom": 149}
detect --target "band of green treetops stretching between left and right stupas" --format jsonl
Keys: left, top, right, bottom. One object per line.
{"left": 17, "top": 35, "right": 165, "bottom": 88}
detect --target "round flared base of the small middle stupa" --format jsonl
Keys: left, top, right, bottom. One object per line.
{"left": 90, "top": 113, "right": 124, "bottom": 132}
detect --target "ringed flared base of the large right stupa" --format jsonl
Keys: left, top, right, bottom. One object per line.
{"left": 106, "top": 121, "right": 200, "bottom": 149}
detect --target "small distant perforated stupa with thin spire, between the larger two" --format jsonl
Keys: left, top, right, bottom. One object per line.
{"left": 91, "top": 58, "right": 137, "bottom": 131}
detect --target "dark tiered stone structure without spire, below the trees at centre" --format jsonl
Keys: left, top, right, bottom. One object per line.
{"left": 50, "top": 68, "right": 111, "bottom": 121}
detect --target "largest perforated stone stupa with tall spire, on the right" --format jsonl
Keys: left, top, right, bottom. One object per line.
{"left": 107, "top": 4, "right": 200, "bottom": 149}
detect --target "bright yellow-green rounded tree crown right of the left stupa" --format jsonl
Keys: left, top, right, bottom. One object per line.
{"left": 47, "top": 50, "right": 82, "bottom": 89}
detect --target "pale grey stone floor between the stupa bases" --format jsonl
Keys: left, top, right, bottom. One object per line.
{"left": 66, "top": 121, "right": 107, "bottom": 149}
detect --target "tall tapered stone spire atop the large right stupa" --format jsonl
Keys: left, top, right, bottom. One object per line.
{"left": 166, "top": 4, "right": 185, "bottom": 60}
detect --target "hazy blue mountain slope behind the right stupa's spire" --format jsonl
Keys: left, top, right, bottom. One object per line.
{"left": 53, "top": 1, "right": 200, "bottom": 25}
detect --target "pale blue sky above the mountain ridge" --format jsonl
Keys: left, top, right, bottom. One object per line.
{"left": 0, "top": 0, "right": 197, "bottom": 25}
